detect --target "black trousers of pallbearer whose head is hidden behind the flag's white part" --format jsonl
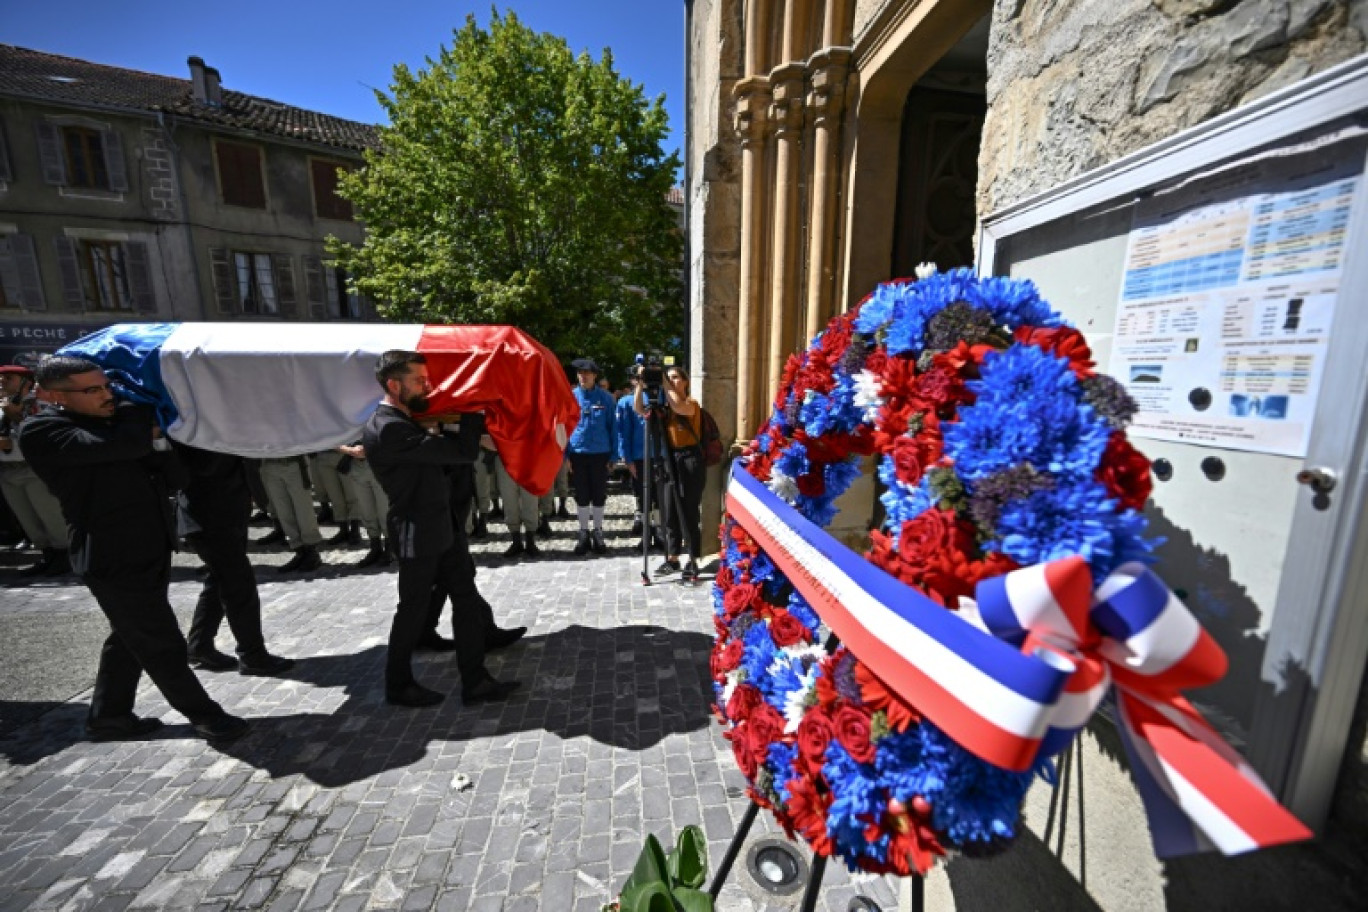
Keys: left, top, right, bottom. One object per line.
{"left": 187, "top": 526, "right": 265, "bottom": 656}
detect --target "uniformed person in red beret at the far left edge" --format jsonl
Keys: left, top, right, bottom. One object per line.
{"left": 0, "top": 364, "right": 71, "bottom": 577}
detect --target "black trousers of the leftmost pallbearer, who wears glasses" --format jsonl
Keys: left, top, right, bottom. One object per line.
{"left": 82, "top": 552, "right": 223, "bottom": 722}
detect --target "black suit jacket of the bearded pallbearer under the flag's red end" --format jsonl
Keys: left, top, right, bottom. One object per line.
{"left": 361, "top": 403, "right": 484, "bottom": 559}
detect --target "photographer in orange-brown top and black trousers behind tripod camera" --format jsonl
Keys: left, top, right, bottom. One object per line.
{"left": 632, "top": 365, "right": 707, "bottom": 582}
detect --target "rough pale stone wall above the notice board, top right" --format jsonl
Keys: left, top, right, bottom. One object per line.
{"left": 978, "top": 0, "right": 1368, "bottom": 215}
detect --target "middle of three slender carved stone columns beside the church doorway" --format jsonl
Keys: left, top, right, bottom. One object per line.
{"left": 766, "top": 63, "right": 806, "bottom": 401}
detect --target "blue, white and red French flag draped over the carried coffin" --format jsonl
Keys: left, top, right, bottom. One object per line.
{"left": 60, "top": 323, "right": 579, "bottom": 495}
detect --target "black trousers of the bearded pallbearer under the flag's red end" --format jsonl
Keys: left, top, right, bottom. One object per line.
{"left": 384, "top": 546, "right": 487, "bottom": 690}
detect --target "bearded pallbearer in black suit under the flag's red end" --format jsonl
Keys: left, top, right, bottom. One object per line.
{"left": 363, "top": 345, "right": 518, "bottom": 706}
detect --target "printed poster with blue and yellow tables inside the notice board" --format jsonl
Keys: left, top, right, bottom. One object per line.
{"left": 1109, "top": 137, "right": 1365, "bottom": 457}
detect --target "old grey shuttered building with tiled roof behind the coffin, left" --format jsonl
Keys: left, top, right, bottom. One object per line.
{"left": 0, "top": 45, "right": 378, "bottom": 358}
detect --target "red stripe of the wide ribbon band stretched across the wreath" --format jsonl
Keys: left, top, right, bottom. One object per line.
{"left": 726, "top": 492, "right": 1040, "bottom": 771}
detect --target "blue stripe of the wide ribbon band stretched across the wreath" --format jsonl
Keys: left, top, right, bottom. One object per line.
{"left": 732, "top": 462, "right": 1068, "bottom": 706}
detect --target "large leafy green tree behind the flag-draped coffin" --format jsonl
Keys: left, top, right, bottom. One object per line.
{"left": 330, "top": 11, "right": 684, "bottom": 371}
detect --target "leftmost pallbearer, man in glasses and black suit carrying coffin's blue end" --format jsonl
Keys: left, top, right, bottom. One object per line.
{"left": 19, "top": 356, "right": 248, "bottom": 742}
